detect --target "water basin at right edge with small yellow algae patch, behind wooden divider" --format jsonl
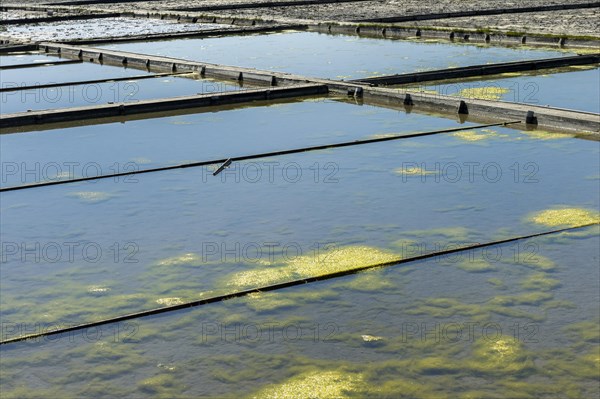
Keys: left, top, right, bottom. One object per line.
{"left": 400, "top": 67, "right": 600, "bottom": 113}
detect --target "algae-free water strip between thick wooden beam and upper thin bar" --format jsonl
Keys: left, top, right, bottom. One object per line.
{"left": 0, "top": 98, "right": 466, "bottom": 186}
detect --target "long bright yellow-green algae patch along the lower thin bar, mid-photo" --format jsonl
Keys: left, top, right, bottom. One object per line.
{"left": 227, "top": 246, "right": 400, "bottom": 287}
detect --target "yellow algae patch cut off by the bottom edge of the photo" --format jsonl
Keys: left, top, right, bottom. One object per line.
{"left": 250, "top": 371, "right": 364, "bottom": 399}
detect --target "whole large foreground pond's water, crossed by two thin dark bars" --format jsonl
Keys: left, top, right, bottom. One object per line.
{"left": 0, "top": 32, "right": 600, "bottom": 398}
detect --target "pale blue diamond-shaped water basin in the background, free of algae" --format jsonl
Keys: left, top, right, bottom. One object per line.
{"left": 98, "top": 32, "right": 576, "bottom": 80}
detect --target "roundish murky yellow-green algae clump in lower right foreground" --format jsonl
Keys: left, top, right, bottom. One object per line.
{"left": 464, "top": 336, "right": 534, "bottom": 375}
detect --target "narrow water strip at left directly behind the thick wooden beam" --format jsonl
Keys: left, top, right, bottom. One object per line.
{"left": 0, "top": 74, "right": 243, "bottom": 113}
